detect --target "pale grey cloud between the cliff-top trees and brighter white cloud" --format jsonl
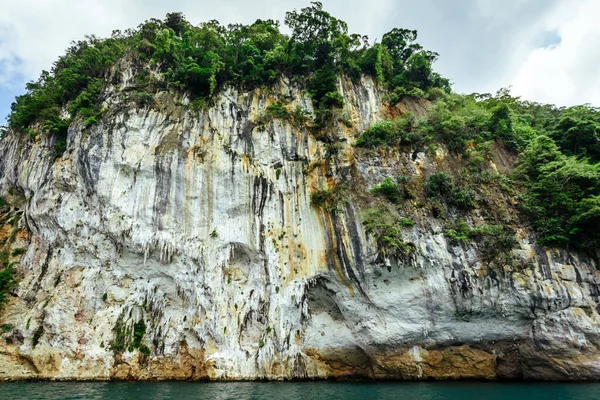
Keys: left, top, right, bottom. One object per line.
{"left": 385, "top": 0, "right": 558, "bottom": 93}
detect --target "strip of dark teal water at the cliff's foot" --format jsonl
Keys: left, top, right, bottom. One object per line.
{"left": 0, "top": 382, "right": 600, "bottom": 400}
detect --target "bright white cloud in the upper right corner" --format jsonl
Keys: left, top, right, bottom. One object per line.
{"left": 513, "top": 0, "right": 600, "bottom": 105}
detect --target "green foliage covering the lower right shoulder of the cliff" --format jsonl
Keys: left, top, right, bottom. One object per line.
{"left": 356, "top": 89, "right": 600, "bottom": 250}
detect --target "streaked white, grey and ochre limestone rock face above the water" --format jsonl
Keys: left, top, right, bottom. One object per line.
{"left": 0, "top": 78, "right": 600, "bottom": 379}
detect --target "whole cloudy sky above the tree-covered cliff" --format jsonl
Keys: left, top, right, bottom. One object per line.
{"left": 0, "top": 0, "right": 600, "bottom": 125}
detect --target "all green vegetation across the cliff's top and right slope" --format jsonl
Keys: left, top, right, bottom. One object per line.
{"left": 2, "top": 2, "right": 600, "bottom": 253}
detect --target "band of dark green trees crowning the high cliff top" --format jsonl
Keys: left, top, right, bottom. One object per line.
{"left": 8, "top": 2, "right": 449, "bottom": 136}
